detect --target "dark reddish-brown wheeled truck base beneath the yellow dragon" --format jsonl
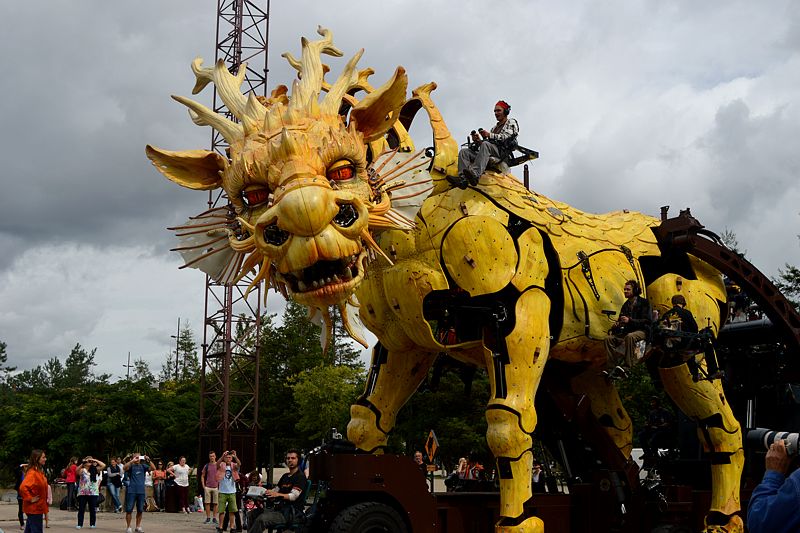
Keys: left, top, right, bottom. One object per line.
{"left": 306, "top": 442, "right": 748, "bottom": 533}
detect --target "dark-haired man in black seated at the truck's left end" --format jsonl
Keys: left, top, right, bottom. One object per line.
{"left": 247, "top": 448, "right": 306, "bottom": 533}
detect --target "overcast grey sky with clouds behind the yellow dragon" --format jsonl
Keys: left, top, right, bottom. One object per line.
{"left": 0, "top": 0, "right": 800, "bottom": 375}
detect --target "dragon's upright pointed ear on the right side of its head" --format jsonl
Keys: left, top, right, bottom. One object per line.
{"left": 350, "top": 67, "right": 408, "bottom": 142}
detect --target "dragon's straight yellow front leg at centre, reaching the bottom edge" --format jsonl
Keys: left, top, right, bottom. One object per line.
{"left": 485, "top": 287, "right": 550, "bottom": 533}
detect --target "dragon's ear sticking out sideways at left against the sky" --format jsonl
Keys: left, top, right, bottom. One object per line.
{"left": 144, "top": 144, "right": 228, "bottom": 191}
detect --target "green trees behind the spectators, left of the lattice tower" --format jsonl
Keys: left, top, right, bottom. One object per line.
{"left": 0, "top": 344, "right": 199, "bottom": 479}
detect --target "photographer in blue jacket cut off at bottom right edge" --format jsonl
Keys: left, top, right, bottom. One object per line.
{"left": 747, "top": 440, "right": 800, "bottom": 533}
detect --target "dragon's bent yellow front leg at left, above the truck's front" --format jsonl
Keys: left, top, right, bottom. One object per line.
{"left": 347, "top": 343, "right": 437, "bottom": 453}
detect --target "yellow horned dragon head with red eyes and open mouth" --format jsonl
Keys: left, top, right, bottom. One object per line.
{"left": 146, "top": 28, "right": 450, "bottom": 350}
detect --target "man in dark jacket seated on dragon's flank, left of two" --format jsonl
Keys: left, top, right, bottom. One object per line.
{"left": 604, "top": 279, "right": 653, "bottom": 378}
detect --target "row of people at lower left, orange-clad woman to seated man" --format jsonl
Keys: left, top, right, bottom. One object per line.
{"left": 14, "top": 444, "right": 306, "bottom": 533}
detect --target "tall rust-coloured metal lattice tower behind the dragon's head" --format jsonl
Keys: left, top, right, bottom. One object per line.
{"left": 198, "top": 0, "right": 269, "bottom": 468}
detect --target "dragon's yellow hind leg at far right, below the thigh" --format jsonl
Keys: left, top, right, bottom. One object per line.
{"left": 659, "top": 363, "right": 744, "bottom": 533}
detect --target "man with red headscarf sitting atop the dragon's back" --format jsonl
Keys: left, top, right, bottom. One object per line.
{"left": 447, "top": 100, "right": 519, "bottom": 189}
